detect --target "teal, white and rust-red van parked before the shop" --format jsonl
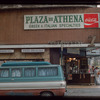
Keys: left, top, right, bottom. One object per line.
{"left": 0, "top": 62, "right": 66, "bottom": 96}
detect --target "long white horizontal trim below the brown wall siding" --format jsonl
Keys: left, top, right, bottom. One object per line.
{"left": 0, "top": 43, "right": 100, "bottom": 49}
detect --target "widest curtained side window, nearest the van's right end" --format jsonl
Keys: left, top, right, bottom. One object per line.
{"left": 38, "top": 67, "right": 58, "bottom": 77}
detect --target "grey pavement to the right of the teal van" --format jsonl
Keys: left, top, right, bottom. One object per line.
{"left": 64, "top": 85, "right": 100, "bottom": 97}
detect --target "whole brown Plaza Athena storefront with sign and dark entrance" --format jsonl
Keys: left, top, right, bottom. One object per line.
{"left": 0, "top": 6, "right": 100, "bottom": 84}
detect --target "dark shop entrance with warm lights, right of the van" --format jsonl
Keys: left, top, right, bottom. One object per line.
{"left": 65, "top": 56, "right": 91, "bottom": 84}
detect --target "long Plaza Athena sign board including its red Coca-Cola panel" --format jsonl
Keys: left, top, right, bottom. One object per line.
{"left": 24, "top": 13, "right": 100, "bottom": 30}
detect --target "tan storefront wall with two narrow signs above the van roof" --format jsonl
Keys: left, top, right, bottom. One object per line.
{"left": 0, "top": 48, "right": 50, "bottom": 65}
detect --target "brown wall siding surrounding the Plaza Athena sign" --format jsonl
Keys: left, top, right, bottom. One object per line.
{"left": 0, "top": 8, "right": 100, "bottom": 44}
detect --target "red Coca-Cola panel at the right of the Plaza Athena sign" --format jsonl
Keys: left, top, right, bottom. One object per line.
{"left": 84, "top": 14, "right": 99, "bottom": 28}
